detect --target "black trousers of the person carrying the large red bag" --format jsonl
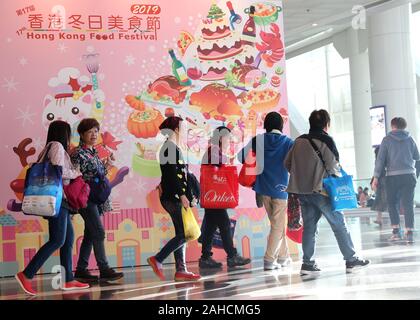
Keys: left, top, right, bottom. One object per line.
{"left": 201, "top": 209, "right": 238, "bottom": 259}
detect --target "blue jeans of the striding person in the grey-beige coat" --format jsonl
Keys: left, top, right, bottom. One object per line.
{"left": 299, "top": 193, "right": 357, "bottom": 265}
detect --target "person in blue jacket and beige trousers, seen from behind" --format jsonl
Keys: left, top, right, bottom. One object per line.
{"left": 238, "top": 112, "right": 293, "bottom": 270}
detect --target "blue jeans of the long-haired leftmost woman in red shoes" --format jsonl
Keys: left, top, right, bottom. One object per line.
{"left": 23, "top": 207, "right": 74, "bottom": 282}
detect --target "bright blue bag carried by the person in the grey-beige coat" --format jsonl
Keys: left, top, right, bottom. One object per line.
{"left": 323, "top": 168, "right": 357, "bottom": 211}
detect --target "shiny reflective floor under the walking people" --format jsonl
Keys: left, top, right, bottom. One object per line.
{"left": 0, "top": 212, "right": 420, "bottom": 300}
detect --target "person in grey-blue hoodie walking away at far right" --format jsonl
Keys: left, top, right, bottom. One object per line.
{"left": 372, "top": 118, "right": 420, "bottom": 244}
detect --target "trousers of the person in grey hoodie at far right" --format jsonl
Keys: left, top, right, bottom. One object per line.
{"left": 385, "top": 174, "right": 417, "bottom": 230}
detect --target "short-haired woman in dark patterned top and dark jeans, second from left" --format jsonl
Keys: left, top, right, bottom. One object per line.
{"left": 71, "top": 118, "right": 124, "bottom": 282}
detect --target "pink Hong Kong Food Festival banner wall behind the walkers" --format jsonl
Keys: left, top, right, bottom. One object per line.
{"left": 0, "top": 0, "right": 288, "bottom": 275}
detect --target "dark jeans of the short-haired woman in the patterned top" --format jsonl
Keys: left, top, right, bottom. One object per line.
{"left": 77, "top": 201, "right": 109, "bottom": 270}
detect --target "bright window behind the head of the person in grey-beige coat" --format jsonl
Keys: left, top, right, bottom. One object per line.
{"left": 286, "top": 44, "right": 356, "bottom": 175}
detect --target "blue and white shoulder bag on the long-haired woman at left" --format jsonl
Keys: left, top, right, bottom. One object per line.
{"left": 22, "top": 146, "right": 63, "bottom": 217}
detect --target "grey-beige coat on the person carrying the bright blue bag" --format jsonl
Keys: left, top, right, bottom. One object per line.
{"left": 284, "top": 138, "right": 340, "bottom": 194}
